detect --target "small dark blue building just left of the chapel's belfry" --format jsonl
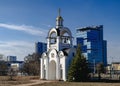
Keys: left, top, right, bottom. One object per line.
{"left": 35, "top": 42, "right": 47, "bottom": 54}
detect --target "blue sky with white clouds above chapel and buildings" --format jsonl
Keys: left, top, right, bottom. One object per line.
{"left": 0, "top": 0, "right": 120, "bottom": 62}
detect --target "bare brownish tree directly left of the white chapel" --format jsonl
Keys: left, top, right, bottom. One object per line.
{"left": 23, "top": 53, "right": 41, "bottom": 75}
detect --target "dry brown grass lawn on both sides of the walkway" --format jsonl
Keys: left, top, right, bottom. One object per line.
{"left": 0, "top": 76, "right": 120, "bottom": 86}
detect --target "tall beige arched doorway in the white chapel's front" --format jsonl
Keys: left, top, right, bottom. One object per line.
{"left": 48, "top": 60, "right": 56, "bottom": 80}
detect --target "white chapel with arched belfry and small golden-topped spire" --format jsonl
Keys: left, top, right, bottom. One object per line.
{"left": 40, "top": 9, "right": 76, "bottom": 81}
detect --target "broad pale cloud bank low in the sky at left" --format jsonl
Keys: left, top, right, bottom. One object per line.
{"left": 0, "top": 41, "right": 35, "bottom": 60}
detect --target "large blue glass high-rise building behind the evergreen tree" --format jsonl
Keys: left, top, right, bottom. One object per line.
{"left": 76, "top": 25, "right": 107, "bottom": 71}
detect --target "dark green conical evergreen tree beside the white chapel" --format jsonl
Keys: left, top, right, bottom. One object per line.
{"left": 67, "top": 45, "right": 89, "bottom": 82}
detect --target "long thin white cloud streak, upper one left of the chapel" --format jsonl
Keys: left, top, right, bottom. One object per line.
{"left": 0, "top": 23, "right": 46, "bottom": 36}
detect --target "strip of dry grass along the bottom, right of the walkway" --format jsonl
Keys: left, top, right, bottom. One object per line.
{"left": 32, "top": 82, "right": 120, "bottom": 86}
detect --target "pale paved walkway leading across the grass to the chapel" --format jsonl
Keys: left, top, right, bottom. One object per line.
{"left": 13, "top": 80, "right": 52, "bottom": 86}
